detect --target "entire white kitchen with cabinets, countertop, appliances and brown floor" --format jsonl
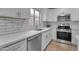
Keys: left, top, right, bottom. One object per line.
{"left": 0, "top": 8, "right": 79, "bottom": 51}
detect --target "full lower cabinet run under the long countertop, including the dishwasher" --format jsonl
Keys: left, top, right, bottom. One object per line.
{"left": 0, "top": 30, "right": 52, "bottom": 51}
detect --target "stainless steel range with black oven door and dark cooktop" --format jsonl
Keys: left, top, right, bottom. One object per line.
{"left": 57, "top": 26, "right": 72, "bottom": 42}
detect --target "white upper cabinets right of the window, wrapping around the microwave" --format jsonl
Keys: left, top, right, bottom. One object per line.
{"left": 41, "top": 8, "right": 79, "bottom": 21}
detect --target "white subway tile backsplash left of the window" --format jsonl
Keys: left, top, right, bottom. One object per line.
{"left": 0, "top": 18, "right": 33, "bottom": 35}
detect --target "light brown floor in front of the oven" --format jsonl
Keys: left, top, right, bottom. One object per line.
{"left": 45, "top": 41, "right": 77, "bottom": 51}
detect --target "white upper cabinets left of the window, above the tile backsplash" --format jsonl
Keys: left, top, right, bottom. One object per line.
{"left": 0, "top": 8, "right": 30, "bottom": 18}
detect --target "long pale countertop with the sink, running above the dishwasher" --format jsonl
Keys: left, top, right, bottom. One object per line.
{"left": 0, "top": 28, "right": 50, "bottom": 46}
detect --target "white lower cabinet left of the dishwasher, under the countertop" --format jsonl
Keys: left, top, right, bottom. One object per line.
{"left": 0, "top": 39, "right": 27, "bottom": 51}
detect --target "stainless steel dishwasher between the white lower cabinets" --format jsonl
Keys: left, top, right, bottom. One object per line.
{"left": 27, "top": 34, "right": 41, "bottom": 51}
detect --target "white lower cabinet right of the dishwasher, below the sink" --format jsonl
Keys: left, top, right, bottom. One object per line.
{"left": 41, "top": 30, "right": 52, "bottom": 51}
